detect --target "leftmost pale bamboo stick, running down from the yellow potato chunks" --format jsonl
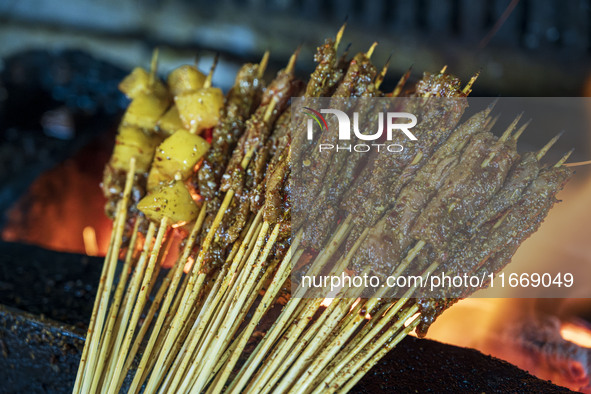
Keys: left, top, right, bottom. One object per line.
{"left": 82, "top": 158, "right": 136, "bottom": 392}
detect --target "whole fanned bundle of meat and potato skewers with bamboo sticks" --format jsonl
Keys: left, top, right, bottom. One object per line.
{"left": 74, "top": 25, "right": 571, "bottom": 393}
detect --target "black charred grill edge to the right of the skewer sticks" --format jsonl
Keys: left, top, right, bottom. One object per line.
{"left": 351, "top": 337, "right": 572, "bottom": 394}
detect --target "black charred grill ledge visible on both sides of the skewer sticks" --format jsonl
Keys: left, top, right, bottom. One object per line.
{"left": 0, "top": 243, "right": 569, "bottom": 393}
